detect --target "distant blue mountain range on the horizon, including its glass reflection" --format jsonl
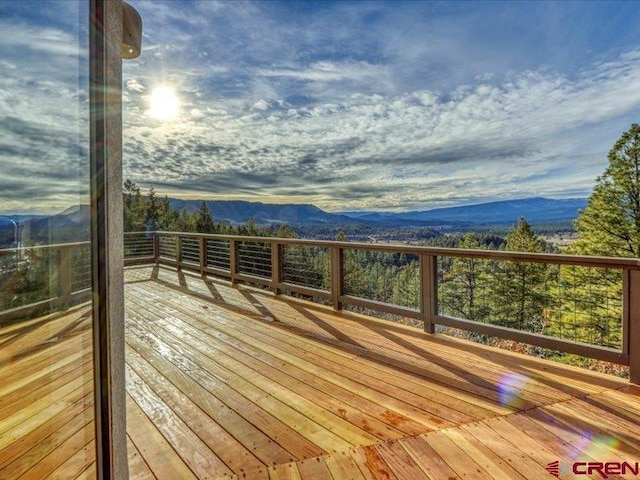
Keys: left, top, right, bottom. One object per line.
{"left": 0, "top": 197, "right": 587, "bottom": 248}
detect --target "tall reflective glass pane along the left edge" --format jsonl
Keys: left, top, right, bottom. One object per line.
{"left": 0, "top": 0, "right": 95, "bottom": 479}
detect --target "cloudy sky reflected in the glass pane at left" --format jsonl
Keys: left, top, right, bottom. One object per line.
{"left": 0, "top": 6, "right": 89, "bottom": 213}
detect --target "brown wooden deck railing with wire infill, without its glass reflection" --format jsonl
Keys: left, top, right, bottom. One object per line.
{"left": 125, "top": 232, "right": 640, "bottom": 383}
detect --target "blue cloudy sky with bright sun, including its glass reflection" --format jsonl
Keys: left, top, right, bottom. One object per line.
{"left": 0, "top": 0, "right": 640, "bottom": 212}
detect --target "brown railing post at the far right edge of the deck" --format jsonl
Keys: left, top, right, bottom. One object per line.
{"left": 623, "top": 270, "right": 640, "bottom": 385}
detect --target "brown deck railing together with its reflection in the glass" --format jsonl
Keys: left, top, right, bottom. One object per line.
{"left": 0, "top": 232, "right": 640, "bottom": 383}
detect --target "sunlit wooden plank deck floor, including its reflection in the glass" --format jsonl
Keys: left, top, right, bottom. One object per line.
{"left": 0, "top": 267, "right": 640, "bottom": 480}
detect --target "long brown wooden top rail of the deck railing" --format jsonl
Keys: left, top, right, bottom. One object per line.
{"left": 151, "top": 231, "right": 640, "bottom": 270}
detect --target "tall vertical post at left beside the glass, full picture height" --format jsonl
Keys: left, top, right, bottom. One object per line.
{"left": 86, "top": 0, "right": 129, "bottom": 479}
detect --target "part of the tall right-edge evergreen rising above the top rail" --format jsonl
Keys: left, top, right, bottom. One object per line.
{"left": 572, "top": 123, "right": 640, "bottom": 257}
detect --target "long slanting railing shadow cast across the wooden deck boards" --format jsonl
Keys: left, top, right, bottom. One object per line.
{"left": 132, "top": 269, "right": 623, "bottom": 416}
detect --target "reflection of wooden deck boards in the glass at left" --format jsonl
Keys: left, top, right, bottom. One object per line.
{"left": 0, "top": 306, "right": 95, "bottom": 480}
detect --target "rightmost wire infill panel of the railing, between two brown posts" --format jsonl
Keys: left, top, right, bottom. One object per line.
{"left": 438, "top": 258, "right": 623, "bottom": 350}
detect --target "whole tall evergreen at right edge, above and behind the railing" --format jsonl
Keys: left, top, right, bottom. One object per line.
{"left": 553, "top": 124, "right": 640, "bottom": 348}
